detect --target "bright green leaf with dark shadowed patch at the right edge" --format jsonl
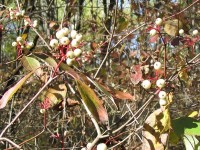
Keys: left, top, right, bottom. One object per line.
{"left": 172, "top": 117, "right": 200, "bottom": 137}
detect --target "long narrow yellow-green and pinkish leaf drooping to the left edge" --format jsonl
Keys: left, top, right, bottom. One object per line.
{"left": 0, "top": 72, "right": 33, "bottom": 109}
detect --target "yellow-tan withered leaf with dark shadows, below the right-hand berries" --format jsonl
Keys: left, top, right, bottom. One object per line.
{"left": 142, "top": 108, "right": 171, "bottom": 150}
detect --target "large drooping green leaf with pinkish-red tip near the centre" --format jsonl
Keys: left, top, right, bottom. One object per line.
{"left": 76, "top": 80, "right": 108, "bottom": 123}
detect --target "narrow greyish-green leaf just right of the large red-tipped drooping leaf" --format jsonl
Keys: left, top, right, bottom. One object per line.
{"left": 88, "top": 78, "right": 118, "bottom": 110}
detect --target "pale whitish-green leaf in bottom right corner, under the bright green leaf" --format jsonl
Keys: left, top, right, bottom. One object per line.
{"left": 183, "top": 135, "right": 200, "bottom": 150}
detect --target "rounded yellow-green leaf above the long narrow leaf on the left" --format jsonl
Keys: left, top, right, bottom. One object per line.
{"left": 21, "top": 56, "right": 43, "bottom": 76}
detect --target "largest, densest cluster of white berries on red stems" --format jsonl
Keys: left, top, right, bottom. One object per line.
{"left": 49, "top": 27, "right": 82, "bottom": 66}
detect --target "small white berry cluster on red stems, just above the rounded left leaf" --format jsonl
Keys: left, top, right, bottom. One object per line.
{"left": 12, "top": 36, "right": 34, "bottom": 57}
